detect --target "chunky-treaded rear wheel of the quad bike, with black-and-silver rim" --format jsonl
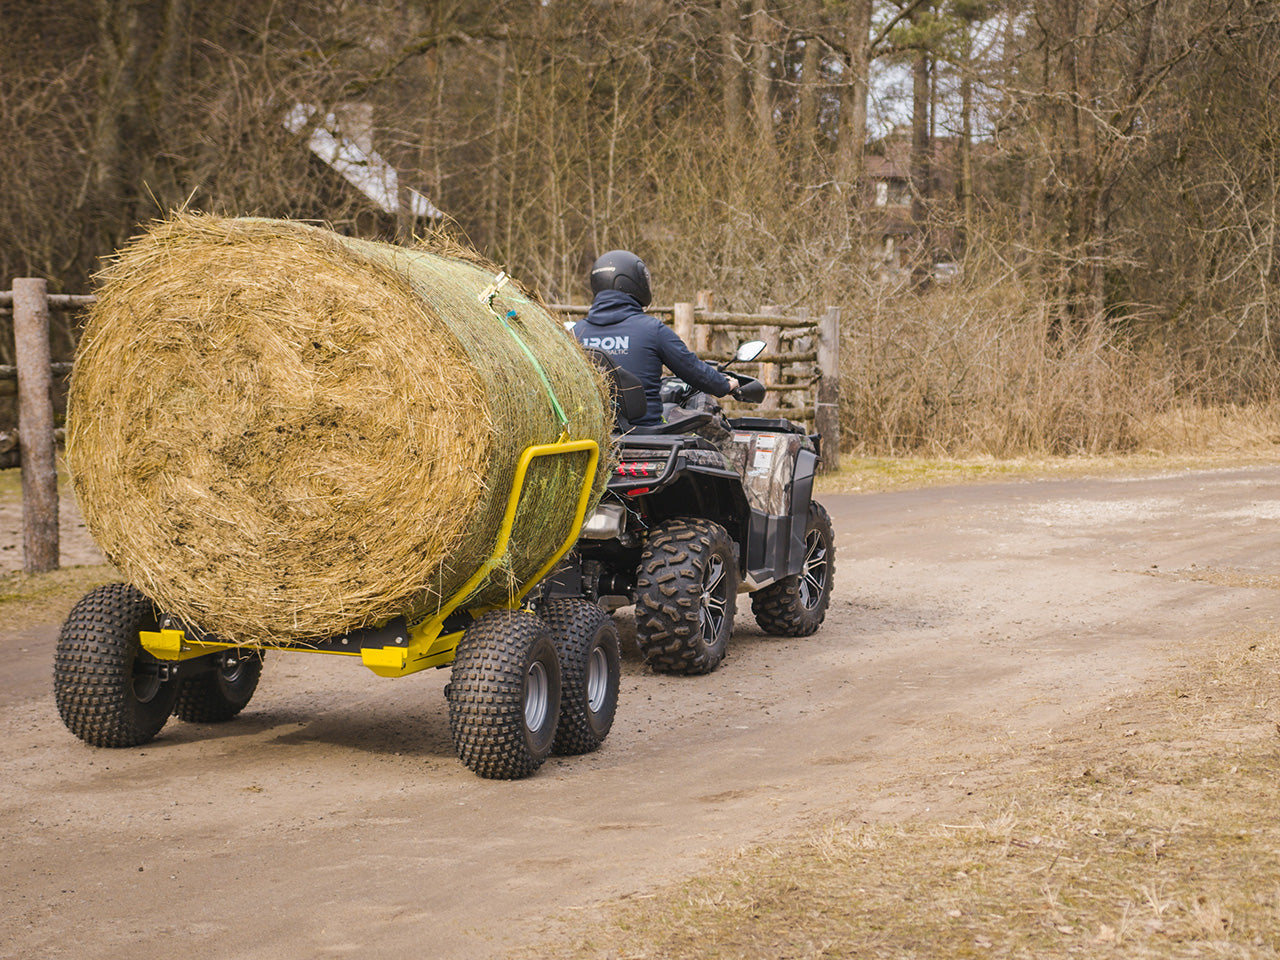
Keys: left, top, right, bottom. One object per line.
{"left": 636, "top": 520, "right": 737, "bottom": 673}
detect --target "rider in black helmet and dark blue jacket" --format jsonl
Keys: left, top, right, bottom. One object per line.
{"left": 573, "top": 250, "right": 740, "bottom": 426}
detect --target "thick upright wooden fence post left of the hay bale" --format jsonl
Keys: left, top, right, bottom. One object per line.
{"left": 13, "top": 278, "right": 59, "bottom": 573}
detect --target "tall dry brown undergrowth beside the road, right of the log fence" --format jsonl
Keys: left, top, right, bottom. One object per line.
{"left": 841, "top": 263, "right": 1280, "bottom": 460}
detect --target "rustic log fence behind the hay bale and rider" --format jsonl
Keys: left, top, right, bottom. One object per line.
{"left": 0, "top": 279, "right": 840, "bottom": 573}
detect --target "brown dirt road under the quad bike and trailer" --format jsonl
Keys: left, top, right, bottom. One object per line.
{"left": 0, "top": 467, "right": 1280, "bottom": 960}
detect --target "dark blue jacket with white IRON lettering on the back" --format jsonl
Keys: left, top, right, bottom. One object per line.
{"left": 573, "top": 291, "right": 730, "bottom": 426}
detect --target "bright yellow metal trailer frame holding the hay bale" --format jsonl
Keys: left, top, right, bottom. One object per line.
{"left": 140, "top": 433, "right": 600, "bottom": 677}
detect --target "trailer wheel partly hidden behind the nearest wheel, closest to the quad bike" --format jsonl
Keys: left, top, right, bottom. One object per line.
{"left": 541, "top": 600, "right": 622, "bottom": 756}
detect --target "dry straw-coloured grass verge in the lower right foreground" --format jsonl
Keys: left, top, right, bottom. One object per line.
{"left": 531, "top": 636, "right": 1280, "bottom": 959}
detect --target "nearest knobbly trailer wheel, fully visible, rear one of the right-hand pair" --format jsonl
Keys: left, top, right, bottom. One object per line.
{"left": 447, "top": 611, "right": 561, "bottom": 780}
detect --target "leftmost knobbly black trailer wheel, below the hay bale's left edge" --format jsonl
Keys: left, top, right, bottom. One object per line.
{"left": 54, "top": 584, "right": 178, "bottom": 746}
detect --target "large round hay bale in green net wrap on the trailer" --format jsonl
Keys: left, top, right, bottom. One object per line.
{"left": 67, "top": 215, "right": 611, "bottom": 643}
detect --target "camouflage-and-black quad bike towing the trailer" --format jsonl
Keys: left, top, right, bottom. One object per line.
{"left": 540, "top": 340, "right": 836, "bottom": 675}
